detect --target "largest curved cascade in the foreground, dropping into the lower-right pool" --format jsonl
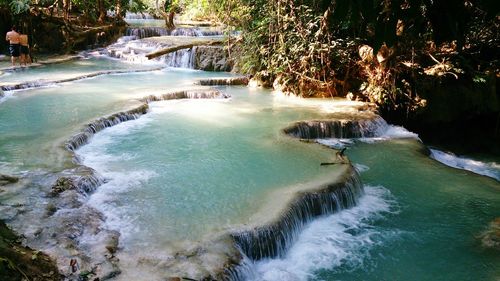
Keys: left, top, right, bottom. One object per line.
{"left": 231, "top": 168, "right": 363, "bottom": 260}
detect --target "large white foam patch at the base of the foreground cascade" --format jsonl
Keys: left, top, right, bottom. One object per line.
{"left": 248, "top": 186, "right": 401, "bottom": 281}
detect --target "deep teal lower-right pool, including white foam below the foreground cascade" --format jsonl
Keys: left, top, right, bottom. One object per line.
{"left": 255, "top": 140, "right": 500, "bottom": 280}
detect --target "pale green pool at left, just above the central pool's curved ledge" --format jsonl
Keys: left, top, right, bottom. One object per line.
{"left": 0, "top": 64, "right": 235, "bottom": 170}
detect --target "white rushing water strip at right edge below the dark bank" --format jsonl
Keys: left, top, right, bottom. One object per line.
{"left": 431, "top": 149, "right": 500, "bottom": 181}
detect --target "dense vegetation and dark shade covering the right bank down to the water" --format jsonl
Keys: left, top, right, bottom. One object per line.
{"left": 190, "top": 0, "right": 500, "bottom": 153}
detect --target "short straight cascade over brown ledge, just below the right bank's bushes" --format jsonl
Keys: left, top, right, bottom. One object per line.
{"left": 283, "top": 116, "right": 388, "bottom": 139}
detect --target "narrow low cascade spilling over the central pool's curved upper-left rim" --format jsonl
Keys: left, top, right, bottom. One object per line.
{"left": 66, "top": 104, "right": 149, "bottom": 151}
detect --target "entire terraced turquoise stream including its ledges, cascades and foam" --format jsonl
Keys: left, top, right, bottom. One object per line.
{"left": 0, "top": 23, "right": 500, "bottom": 281}
